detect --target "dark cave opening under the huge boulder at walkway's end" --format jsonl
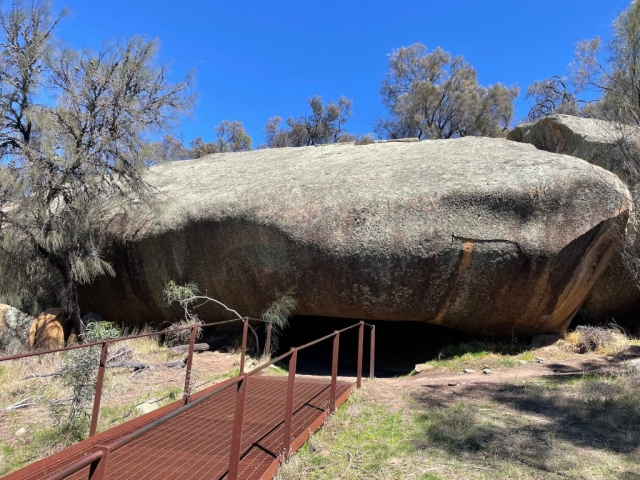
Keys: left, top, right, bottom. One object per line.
{"left": 277, "top": 316, "right": 471, "bottom": 377}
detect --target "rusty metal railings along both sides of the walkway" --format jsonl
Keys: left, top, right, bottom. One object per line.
{"left": 0, "top": 318, "right": 375, "bottom": 480}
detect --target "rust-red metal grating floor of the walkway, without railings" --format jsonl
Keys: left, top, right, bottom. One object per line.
{"left": 5, "top": 376, "right": 353, "bottom": 480}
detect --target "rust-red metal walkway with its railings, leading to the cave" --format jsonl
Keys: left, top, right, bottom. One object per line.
{"left": 0, "top": 319, "right": 375, "bottom": 480}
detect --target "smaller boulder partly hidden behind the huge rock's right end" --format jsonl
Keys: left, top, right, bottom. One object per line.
{"left": 507, "top": 115, "right": 640, "bottom": 320}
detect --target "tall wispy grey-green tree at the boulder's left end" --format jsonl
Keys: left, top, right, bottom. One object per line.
{"left": 0, "top": 1, "right": 193, "bottom": 333}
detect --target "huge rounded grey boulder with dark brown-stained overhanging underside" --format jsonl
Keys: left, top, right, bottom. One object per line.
{"left": 76, "top": 138, "right": 630, "bottom": 335}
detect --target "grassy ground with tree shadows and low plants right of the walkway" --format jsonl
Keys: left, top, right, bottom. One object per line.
{"left": 278, "top": 329, "right": 640, "bottom": 480}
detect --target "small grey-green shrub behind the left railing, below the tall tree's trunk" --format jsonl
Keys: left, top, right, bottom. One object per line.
{"left": 49, "top": 321, "right": 121, "bottom": 443}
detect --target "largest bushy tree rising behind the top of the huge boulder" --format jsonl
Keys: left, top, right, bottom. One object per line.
{"left": 376, "top": 43, "right": 519, "bottom": 139}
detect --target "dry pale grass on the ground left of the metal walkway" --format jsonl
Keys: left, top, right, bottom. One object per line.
{"left": 0, "top": 331, "right": 249, "bottom": 476}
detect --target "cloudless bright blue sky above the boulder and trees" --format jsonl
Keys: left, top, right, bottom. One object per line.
{"left": 54, "top": 0, "right": 630, "bottom": 146}
